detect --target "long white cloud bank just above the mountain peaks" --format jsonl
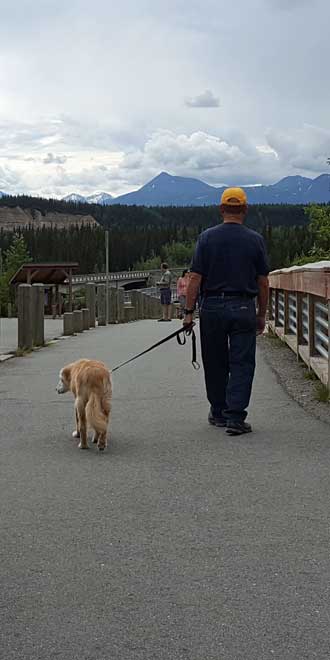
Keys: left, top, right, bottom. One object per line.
{"left": 0, "top": 125, "right": 330, "bottom": 197}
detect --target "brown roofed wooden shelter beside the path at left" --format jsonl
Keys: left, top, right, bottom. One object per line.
{"left": 10, "top": 262, "right": 79, "bottom": 315}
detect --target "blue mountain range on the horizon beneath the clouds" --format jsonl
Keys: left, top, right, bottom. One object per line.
{"left": 0, "top": 172, "right": 330, "bottom": 206}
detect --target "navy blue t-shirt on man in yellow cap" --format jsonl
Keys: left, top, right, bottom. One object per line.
{"left": 191, "top": 222, "right": 269, "bottom": 296}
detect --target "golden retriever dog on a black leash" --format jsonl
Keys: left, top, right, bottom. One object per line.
{"left": 56, "top": 360, "right": 112, "bottom": 451}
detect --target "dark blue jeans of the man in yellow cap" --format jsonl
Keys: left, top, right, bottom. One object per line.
{"left": 200, "top": 296, "right": 256, "bottom": 422}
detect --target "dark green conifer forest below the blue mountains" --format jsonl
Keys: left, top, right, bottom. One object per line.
{"left": 0, "top": 196, "right": 330, "bottom": 273}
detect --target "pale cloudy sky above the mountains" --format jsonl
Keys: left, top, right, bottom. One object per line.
{"left": 0, "top": 0, "right": 330, "bottom": 196}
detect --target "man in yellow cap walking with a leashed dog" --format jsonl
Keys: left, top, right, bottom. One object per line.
{"left": 183, "top": 188, "right": 269, "bottom": 435}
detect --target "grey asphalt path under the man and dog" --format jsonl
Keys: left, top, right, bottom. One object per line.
{"left": 0, "top": 321, "right": 330, "bottom": 660}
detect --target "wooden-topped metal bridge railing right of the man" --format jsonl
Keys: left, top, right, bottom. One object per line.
{"left": 269, "top": 261, "right": 330, "bottom": 387}
